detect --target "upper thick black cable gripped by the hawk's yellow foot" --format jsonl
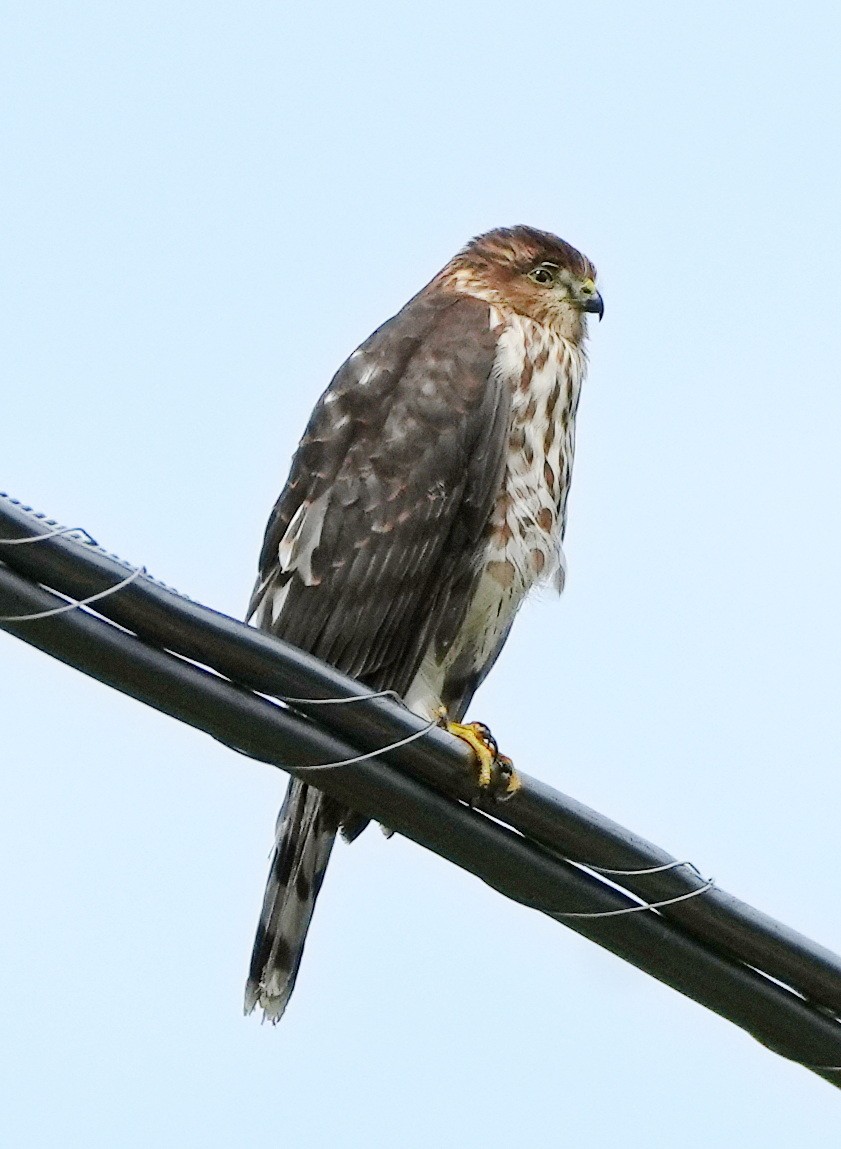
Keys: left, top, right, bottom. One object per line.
{"left": 0, "top": 495, "right": 841, "bottom": 1015}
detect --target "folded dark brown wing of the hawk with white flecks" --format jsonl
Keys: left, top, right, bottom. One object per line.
{"left": 249, "top": 291, "right": 510, "bottom": 694}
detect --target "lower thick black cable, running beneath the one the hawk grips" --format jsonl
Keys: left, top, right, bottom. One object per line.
{"left": 0, "top": 565, "right": 841, "bottom": 1086}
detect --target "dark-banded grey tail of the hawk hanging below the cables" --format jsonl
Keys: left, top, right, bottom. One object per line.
{"left": 245, "top": 778, "right": 341, "bottom": 1021}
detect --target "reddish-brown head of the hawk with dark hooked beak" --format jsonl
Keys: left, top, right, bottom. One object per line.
{"left": 439, "top": 226, "right": 604, "bottom": 342}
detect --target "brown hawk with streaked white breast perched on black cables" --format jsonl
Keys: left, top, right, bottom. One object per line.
{"left": 245, "top": 226, "right": 603, "bottom": 1021}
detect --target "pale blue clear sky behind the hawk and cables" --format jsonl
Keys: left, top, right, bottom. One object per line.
{"left": 0, "top": 0, "right": 841, "bottom": 1149}
